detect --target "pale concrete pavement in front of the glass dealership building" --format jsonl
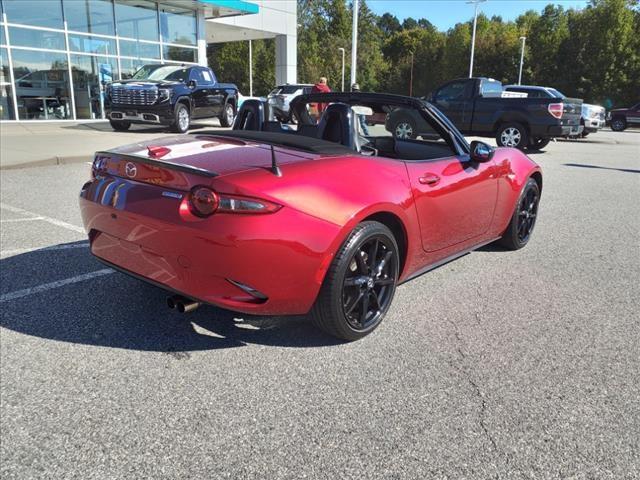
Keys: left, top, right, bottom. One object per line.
{"left": 0, "top": 120, "right": 229, "bottom": 170}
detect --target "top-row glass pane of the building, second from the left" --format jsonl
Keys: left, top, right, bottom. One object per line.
{"left": 64, "top": 0, "right": 116, "bottom": 35}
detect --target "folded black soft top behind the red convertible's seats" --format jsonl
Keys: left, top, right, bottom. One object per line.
{"left": 194, "top": 130, "right": 355, "bottom": 155}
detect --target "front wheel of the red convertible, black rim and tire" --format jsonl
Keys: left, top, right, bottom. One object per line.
{"left": 498, "top": 178, "right": 540, "bottom": 250}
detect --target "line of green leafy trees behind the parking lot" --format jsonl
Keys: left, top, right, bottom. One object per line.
{"left": 208, "top": 0, "right": 640, "bottom": 108}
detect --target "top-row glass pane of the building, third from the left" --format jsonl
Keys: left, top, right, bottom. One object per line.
{"left": 116, "top": 0, "right": 159, "bottom": 42}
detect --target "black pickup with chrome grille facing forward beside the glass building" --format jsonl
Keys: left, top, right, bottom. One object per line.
{"left": 105, "top": 65, "right": 238, "bottom": 133}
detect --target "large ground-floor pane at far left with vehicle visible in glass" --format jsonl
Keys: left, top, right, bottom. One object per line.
{"left": 11, "top": 49, "right": 72, "bottom": 120}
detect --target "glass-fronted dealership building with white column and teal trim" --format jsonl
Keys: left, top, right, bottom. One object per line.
{"left": 0, "top": 0, "right": 297, "bottom": 121}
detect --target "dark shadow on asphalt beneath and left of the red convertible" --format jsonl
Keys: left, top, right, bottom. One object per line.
{"left": 0, "top": 242, "right": 342, "bottom": 350}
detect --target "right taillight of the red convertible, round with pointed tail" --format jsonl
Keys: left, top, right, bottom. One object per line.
{"left": 187, "top": 187, "right": 281, "bottom": 218}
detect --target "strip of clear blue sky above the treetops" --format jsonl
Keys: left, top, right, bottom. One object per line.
{"left": 367, "top": 0, "right": 587, "bottom": 30}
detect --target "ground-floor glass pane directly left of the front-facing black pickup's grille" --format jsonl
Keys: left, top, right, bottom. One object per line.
{"left": 71, "top": 55, "right": 118, "bottom": 119}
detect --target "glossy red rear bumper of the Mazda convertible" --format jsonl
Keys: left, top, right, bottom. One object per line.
{"left": 80, "top": 181, "right": 339, "bottom": 315}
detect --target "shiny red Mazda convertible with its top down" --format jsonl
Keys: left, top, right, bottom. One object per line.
{"left": 80, "top": 93, "right": 542, "bottom": 340}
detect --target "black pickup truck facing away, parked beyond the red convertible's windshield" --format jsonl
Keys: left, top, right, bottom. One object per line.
{"left": 386, "top": 78, "right": 583, "bottom": 150}
